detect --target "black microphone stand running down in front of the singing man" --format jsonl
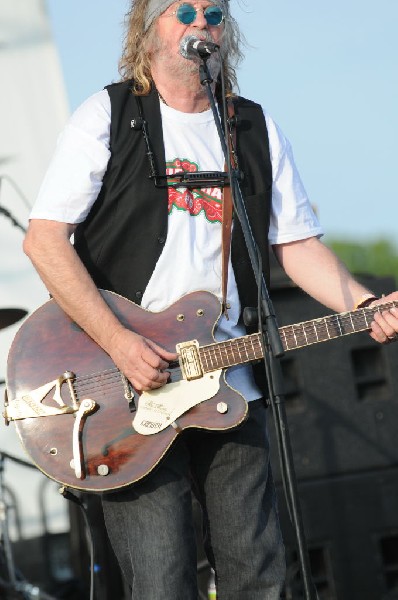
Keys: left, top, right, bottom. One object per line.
{"left": 199, "top": 53, "right": 318, "bottom": 600}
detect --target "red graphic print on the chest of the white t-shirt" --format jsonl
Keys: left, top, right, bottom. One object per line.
{"left": 166, "top": 158, "right": 222, "bottom": 223}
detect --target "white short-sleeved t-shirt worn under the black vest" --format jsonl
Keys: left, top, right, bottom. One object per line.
{"left": 30, "top": 90, "right": 322, "bottom": 400}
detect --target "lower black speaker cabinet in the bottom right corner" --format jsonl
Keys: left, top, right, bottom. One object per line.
{"left": 277, "top": 468, "right": 398, "bottom": 600}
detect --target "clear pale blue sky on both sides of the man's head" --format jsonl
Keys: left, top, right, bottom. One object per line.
{"left": 45, "top": 0, "right": 398, "bottom": 241}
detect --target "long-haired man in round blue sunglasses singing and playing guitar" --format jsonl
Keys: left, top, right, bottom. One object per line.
{"left": 24, "top": 0, "right": 398, "bottom": 600}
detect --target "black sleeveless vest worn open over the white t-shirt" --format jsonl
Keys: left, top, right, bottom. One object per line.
{"left": 74, "top": 82, "right": 272, "bottom": 392}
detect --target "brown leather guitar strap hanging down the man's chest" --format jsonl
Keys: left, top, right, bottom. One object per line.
{"left": 221, "top": 98, "right": 238, "bottom": 319}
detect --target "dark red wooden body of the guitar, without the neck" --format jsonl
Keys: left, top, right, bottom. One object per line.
{"left": 6, "top": 292, "right": 247, "bottom": 492}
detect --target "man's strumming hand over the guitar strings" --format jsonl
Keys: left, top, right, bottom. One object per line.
{"left": 110, "top": 328, "right": 177, "bottom": 392}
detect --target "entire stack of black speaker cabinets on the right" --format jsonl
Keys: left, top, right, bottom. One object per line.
{"left": 269, "top": 264, "right": 398, "bottom": 600}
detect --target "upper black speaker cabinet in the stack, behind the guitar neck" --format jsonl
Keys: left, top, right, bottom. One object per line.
{"left": 270, "top": 278, "right": 398, "bottom": 480}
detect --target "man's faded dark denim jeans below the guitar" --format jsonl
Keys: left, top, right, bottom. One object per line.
{"left": 103, "top": 400, "right": 285, "bottom": 600}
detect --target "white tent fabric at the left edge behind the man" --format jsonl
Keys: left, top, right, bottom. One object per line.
{"left": 0, "top": 0, "right": 69, "bottom": 535}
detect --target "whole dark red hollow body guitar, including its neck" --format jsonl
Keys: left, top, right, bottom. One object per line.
{"left": 4, "top": 291, "right": 398, "bottom": 492}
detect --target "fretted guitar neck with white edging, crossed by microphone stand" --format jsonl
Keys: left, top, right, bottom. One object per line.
{"left": 199, "top": 302, "right": 398, "bottom": 373}
